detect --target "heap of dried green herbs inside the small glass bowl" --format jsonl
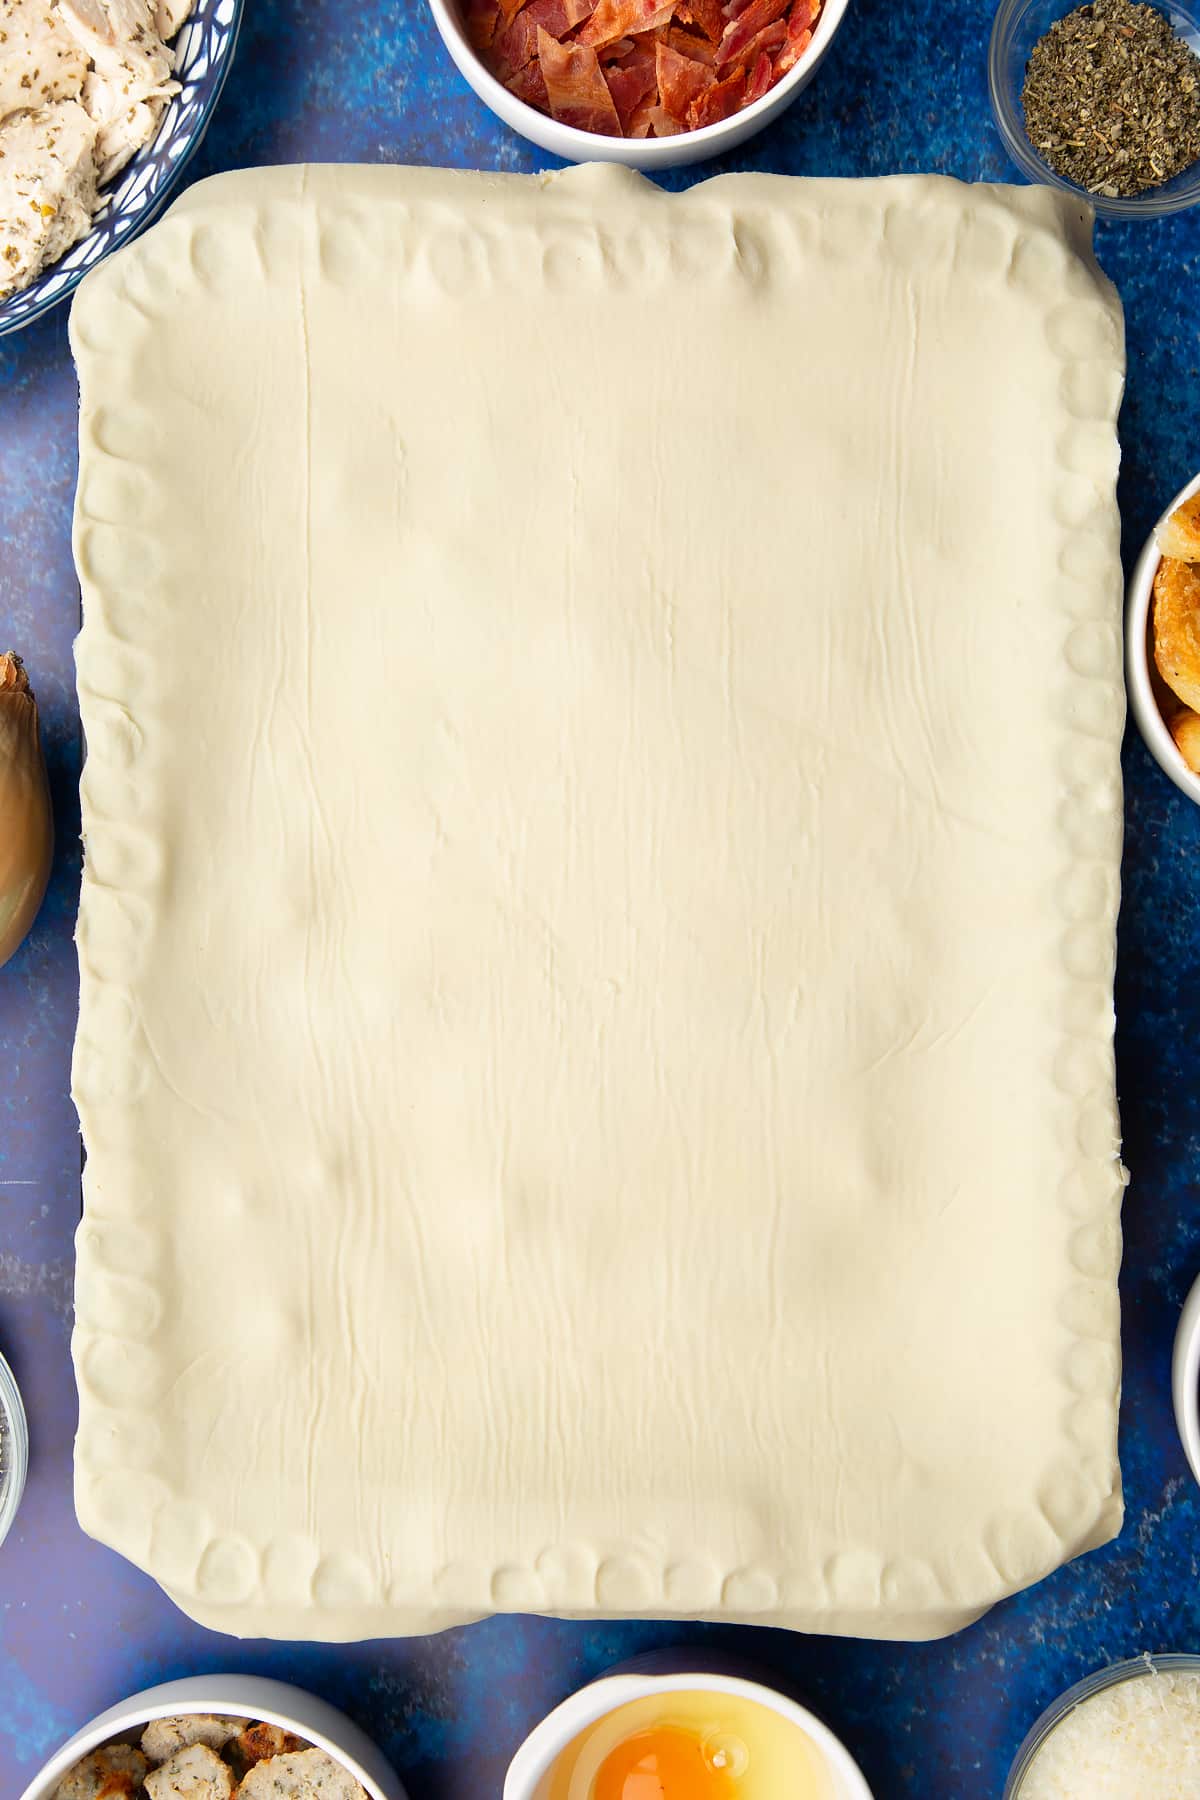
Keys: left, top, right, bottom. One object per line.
{"left": 1022, "top": 0, "right": 1200, "bottom": 198}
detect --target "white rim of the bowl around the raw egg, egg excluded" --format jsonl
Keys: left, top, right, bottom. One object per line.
{"left": 504, "top": 1658, "right": 871, "bottom": 1800}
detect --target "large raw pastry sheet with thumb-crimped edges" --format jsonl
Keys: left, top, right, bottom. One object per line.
{"left": 72, "top": 167, "right": 1123, "bottom": 1638}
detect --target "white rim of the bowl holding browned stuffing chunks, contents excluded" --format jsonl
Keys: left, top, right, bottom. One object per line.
{"left": 22, "top": 1676, "right": 405, "bottom": 1800}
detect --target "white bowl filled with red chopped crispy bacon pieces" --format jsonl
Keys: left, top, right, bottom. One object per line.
{"left": 430, "top": 0, "right": 849, "bottom": 169}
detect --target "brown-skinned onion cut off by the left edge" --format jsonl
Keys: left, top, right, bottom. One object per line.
{"left": 0, "top": 650, "right": 54, "bottom": 968}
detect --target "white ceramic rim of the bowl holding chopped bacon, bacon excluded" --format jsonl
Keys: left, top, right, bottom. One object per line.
{"left": 430, "top": 0, "right": 849, "bottom": 169}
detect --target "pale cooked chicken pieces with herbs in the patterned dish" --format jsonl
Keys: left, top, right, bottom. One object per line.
{"left": 0, "top": 0, "right": 193, "bottom": 299}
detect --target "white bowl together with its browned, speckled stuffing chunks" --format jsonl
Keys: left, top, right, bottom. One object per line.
{"left": 22, "top": 1676, "right": 405, "bottom": 1800}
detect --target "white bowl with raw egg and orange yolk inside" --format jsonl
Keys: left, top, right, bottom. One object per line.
{"left": 502, "top": 1651, "right": 871, "bottom": 1800}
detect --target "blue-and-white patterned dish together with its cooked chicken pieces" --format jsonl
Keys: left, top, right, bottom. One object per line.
{"left": 0, "top": 0, "right": 243, "bottom": 337}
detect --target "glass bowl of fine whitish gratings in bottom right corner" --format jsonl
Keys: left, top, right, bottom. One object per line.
{"left": 1004, "top": 1652, "right": 1200, "bottom": 1800}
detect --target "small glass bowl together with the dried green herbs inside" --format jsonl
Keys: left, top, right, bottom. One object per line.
{"left": 988, "top": 0, "right": 1200, "bottom": 218}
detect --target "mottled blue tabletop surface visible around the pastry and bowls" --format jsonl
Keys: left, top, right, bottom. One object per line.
{"left": 0, "top": 0, "right": 1200, "bottom": 1800}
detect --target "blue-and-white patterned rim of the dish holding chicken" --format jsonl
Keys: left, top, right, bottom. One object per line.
{"left": 0, "top": 0, "right": 243, "bottom": 337}
